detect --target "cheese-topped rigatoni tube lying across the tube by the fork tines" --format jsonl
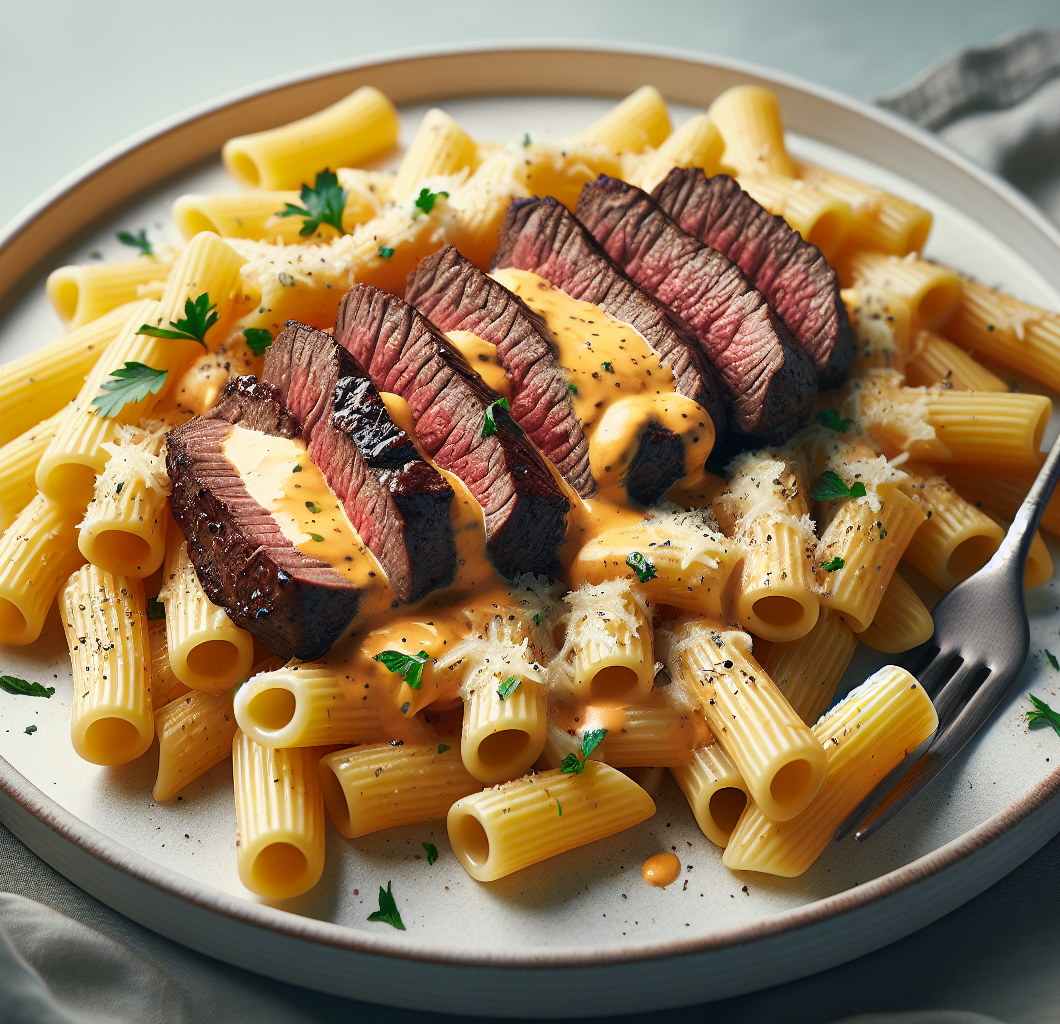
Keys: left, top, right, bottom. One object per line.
{"left": 670, "top": 621, "right": 825, "bottom": 822}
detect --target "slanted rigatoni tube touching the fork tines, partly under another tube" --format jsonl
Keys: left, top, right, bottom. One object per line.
{"left": 723, "top": 665, "right": 938, "bottom": 878}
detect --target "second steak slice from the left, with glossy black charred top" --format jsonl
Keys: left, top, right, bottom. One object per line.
{"left": 262, "top": 321, "right": 457, "bottom": 601}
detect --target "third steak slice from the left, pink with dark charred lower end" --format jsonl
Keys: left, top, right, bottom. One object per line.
{"left": 335, "top": 284, "right": 570, "bottom": 579}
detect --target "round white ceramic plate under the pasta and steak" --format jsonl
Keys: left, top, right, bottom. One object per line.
{"left": 0, "top": 48, "right": 1060, "bottom": 1017}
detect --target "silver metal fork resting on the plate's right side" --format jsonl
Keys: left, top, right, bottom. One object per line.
{"left": 835, "top": 428, "right": 1060, "bottom": 841}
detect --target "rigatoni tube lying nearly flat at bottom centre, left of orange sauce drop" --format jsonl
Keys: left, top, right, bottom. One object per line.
{"left": 446, "top": 760, "right": 655, "bottom": 882}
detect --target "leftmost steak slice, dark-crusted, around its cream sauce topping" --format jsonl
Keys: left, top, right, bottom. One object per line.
{"left": 165, "top": 376, "right": 360, "bottom": 660}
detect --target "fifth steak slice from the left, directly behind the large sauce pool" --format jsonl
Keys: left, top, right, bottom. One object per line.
{"left": 491, "top": 196, "right": 728, "bottom": 444}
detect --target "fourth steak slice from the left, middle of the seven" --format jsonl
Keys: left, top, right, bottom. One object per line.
{"left": 405, "top": 245, "right": 597, "bottom": 498}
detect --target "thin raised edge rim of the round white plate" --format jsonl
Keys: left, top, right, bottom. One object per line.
{"left": 0, "top": 40, "right": 1060, "bottom": 969}
